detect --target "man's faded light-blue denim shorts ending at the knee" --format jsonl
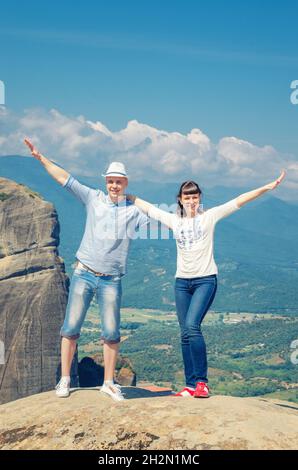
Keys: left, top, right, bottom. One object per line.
{"left": 60, "top": 268, "right": 122, "bottom": 343}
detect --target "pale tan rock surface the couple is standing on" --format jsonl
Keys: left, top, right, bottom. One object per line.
{"left": 0, "top": 387, "right": 298, "bottom": 450}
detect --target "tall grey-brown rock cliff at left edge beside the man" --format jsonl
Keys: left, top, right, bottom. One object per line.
{"left": 0, "top": 178, "right": 69, "bottom": 403}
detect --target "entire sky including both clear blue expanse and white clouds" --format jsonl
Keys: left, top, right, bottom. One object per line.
{"left": 0, "top": 0, "right": 298, "bottom": 200}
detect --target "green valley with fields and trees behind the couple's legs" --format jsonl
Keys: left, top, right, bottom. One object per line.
{"left": 79, "top": 305, "right": 298, "bottom": 403}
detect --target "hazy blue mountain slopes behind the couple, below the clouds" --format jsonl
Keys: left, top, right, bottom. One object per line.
{"left": 0, "top": 156, "right": 298, "bottom": 314}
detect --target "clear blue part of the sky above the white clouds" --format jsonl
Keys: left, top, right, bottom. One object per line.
{"left": 0, "top": 0, "right": 298, "bottom": 155}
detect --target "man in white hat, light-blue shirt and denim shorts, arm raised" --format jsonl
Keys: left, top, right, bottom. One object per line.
{"left": 24, "top": 139, "right": 149, "bottom": 401}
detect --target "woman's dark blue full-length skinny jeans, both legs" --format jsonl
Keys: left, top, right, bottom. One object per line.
{"left": 175, "top": 274, "right": 217, "bottom": 388}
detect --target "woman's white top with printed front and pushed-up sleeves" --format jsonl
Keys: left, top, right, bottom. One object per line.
{"left": 148, "top": 199, "right": 240, "bottom": 279}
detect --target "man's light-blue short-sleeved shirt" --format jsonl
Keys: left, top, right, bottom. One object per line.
{"left": 63, "top": 175, "right": 149, "bottom": 275}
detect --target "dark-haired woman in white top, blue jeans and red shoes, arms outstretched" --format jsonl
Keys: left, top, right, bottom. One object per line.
{"left": 127, "top": 171, "right": 285, "bottom": 398}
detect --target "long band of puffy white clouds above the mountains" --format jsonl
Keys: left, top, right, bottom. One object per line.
{"left": 0, "top": 108, "right": 298, "bottom": 197}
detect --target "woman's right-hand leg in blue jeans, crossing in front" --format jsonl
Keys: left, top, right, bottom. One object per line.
{"left": 185, "top": 277, "right": 217, "bottom": 383}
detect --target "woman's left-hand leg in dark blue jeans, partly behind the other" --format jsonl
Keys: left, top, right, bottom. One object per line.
{"left": 175, "top": 278, "right": 196, "bottom": 388}
